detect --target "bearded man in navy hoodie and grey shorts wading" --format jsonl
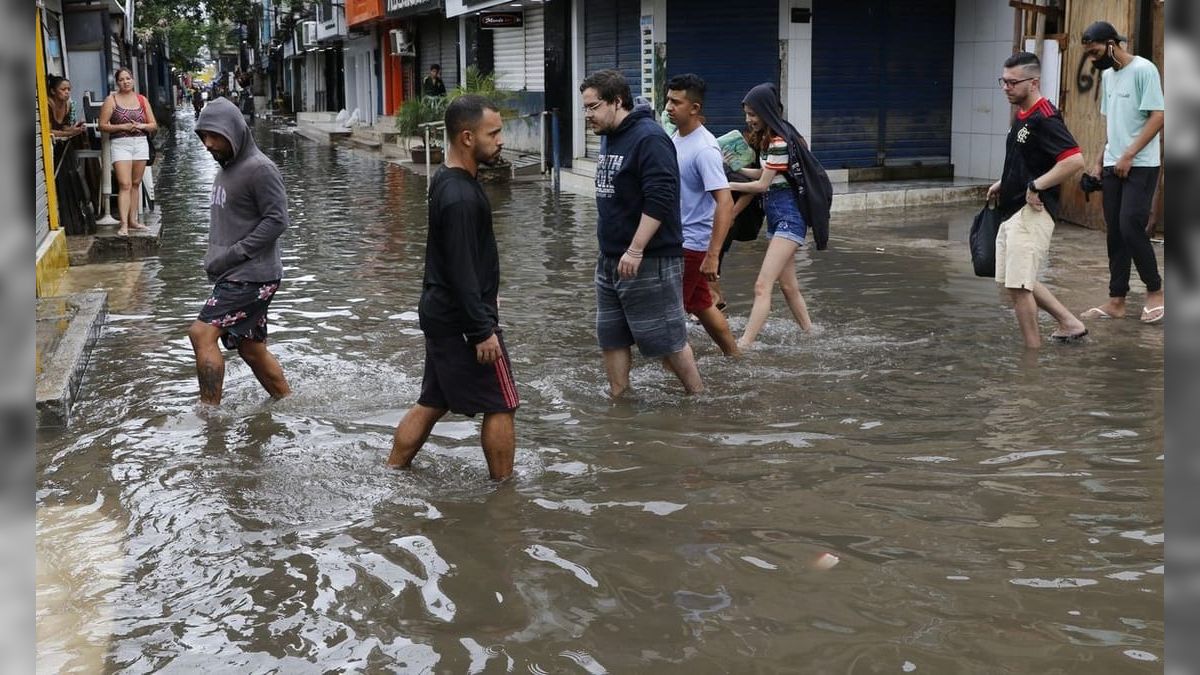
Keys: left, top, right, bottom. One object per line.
{"left": 580, "top": 70, "right": 704, "bottom": 398}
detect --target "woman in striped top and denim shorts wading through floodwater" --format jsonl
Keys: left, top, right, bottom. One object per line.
{"left": 730, "top": 85, "right": 812, "bottom": 351}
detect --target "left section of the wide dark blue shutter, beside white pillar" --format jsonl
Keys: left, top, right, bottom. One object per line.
{"left": 812, "top": 0, "right": 888, "bottom": 168}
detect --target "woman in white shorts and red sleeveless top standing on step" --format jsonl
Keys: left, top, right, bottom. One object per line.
{"left": 100, "top": 68, "right": 158, "bottom": 235}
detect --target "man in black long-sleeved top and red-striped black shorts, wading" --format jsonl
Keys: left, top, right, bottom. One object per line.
{"left": 388, "top": 95, "right": 521, "bottom": 480}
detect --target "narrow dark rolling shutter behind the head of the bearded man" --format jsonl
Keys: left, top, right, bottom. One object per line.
{"left": 583, "top": 0, "right": 642, "bottom": 157}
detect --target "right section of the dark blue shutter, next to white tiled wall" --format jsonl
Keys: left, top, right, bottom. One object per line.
{"left": 882, "top": 0, "right": 950, "bottom": 166}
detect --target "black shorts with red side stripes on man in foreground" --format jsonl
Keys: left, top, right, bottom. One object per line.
{"left": 416, "top": 330, "right": 521, "bottom": 416}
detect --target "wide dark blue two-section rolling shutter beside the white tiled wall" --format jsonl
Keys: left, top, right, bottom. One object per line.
{"left": 812, "top": 0, "right": 954, "bottom": 168}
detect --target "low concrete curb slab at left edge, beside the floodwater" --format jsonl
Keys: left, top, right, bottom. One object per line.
{"left": 35, "top": 291, "right": 108, "bottom": 428}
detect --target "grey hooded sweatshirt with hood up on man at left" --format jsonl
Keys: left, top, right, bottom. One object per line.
{"left": 196, "top": 98, "right": 288, "bottom": 282}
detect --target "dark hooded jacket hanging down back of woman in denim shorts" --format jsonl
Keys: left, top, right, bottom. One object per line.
{"left": 742, "top": 82, "right": 833, "bottom": 251}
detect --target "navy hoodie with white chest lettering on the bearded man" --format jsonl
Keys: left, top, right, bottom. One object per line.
{"left": 596, "top": 104, "right": 683, "bottom": 258}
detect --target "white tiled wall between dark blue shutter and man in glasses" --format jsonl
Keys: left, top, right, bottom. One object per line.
{"left": 950, "top": 0, "right": 1015, "bottom": 179}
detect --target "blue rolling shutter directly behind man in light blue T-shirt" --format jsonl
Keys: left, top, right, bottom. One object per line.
{"left": 664, "top": 0, "right": 779, "bottom": 136}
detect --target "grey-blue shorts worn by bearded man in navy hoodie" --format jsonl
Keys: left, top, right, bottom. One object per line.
{"left": 596, "top": 256, "right": 688, "bottom": 358}
